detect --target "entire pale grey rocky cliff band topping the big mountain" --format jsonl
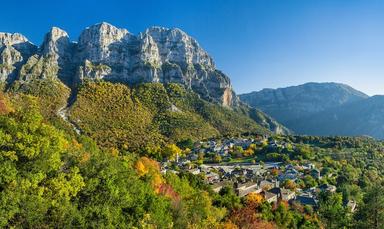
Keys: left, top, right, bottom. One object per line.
{"left": 0, "top": 23, "right": 234, "bottom": 107}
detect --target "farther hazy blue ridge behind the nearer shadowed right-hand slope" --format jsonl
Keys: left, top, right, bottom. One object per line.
{"left": 239, "top": 83, "right": 368, "bottom": 124}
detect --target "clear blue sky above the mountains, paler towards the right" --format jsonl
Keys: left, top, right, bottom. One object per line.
{"left": 0, "top": 0, "right": 384, "bottom": 95}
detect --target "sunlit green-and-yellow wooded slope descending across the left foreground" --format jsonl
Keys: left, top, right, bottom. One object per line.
{"left": 0, "top": 92, "right": 225, "bottom": 228}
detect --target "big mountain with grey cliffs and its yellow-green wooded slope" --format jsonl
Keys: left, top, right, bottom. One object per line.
{"left": 0, "top": 23, "right": 288, "bottom": 147}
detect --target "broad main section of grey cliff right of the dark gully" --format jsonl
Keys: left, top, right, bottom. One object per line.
{"left": 75, "top": 23, "right": 238, "bottom": 106}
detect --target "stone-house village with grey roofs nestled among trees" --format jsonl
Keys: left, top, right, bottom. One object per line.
{"left": 162, "top": 136, "right": 357, "bottom": 212}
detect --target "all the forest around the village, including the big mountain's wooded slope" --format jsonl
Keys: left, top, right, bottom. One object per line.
{"left": 0, "top": 82, "right": 384, "bottom": 228}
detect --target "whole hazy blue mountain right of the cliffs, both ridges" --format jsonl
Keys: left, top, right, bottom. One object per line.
{"left": 239, "top": 83, "right": 384, "bottom": 138}
